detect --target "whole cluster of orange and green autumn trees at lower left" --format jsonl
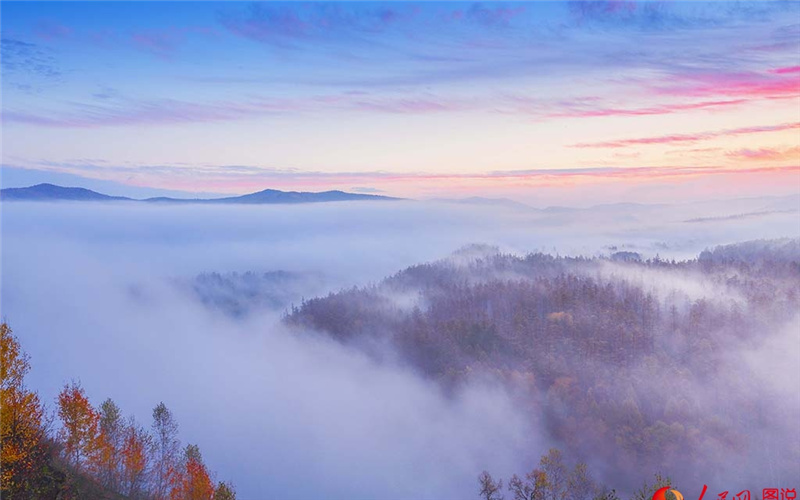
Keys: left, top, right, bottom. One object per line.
{"left": 0, "top": 323, "right": 236, "bottom": 500}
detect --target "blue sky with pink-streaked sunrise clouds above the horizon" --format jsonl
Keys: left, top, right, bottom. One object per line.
{"left": 0, "top": 0, "right": 800, "bottom": 205}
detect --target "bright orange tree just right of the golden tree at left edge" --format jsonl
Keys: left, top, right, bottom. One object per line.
{"left": 57, "top": 381, "right": 98, "bottom": 471}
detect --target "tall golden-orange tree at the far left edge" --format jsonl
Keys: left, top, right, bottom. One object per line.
{"left": 0, "top": 323, "right": 48, "bottom": 499}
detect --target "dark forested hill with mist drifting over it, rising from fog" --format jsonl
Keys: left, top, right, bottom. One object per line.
{"left": 285, "top": 240, "right": 800, "bottom": 488}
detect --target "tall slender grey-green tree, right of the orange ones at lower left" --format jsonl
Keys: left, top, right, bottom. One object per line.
{"left": 152, "top": 402, "right": 180, "bottom": 500}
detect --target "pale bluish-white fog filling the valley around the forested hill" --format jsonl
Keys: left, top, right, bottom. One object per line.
{"left": 0, "top": 197, "right": 800, "bottom": 499}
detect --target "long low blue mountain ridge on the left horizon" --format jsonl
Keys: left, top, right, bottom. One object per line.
{"left": 0, "top": 184, "right": 400, "bottom": 204}
